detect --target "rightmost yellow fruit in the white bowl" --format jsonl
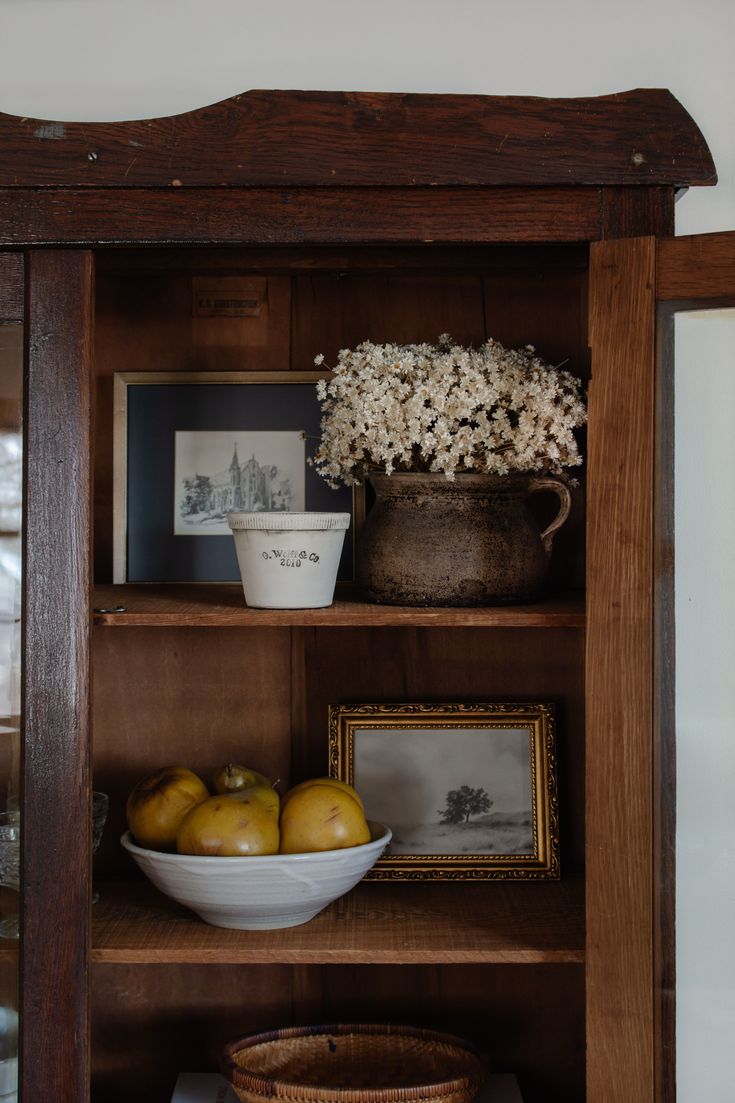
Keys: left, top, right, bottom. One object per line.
{"left": 280, "top": 785, "right": 370, "bottom": 854}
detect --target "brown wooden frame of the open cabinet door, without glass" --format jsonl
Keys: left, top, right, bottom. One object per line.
{"left": 586, "top": 226, "right": 735, "bottom": 1103}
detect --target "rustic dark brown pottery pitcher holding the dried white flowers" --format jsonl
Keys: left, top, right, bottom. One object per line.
{"left": 358, "top": 473, "right": 572, "bottom": 606}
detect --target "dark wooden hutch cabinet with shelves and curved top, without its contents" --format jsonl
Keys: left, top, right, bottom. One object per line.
{"left": 0, "top": 90, "right": 735, "bottom": 1103}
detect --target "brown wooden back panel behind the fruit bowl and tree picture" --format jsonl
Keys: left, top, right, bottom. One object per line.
{"left": 93, "top": 628, "right": 584, "bottom": 875}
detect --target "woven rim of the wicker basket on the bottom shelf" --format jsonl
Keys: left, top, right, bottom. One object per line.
{"left": 222, "top": 1022, "right": 489, "bottom": 1101}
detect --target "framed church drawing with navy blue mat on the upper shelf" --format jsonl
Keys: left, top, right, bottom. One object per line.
{"left": 113, "top": 372, "right": 356, "bottom": 582}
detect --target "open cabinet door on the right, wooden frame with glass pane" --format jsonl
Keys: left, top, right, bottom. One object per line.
{"left": 586, "top": 233, "right": 735, "bottom": 1103}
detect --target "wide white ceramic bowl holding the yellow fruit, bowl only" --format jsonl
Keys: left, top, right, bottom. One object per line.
{"left": 120, "top": 821, "right": 391, "bottom": 931}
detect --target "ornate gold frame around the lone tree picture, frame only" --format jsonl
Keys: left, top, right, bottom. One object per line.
{"left": 329, "top": 704, "right": 560, "bottom": 880}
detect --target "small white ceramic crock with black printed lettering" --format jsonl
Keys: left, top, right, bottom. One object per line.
{"left": 227, "top": 511, "right": 350, "bottom": 609}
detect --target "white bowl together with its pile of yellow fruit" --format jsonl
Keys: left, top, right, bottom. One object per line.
{"left": 120, "top": 764, "right": 391, "bottom": 931}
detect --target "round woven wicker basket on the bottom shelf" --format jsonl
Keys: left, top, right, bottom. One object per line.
{"left": 223, "top": 1025, "right": 487, "bottom": 1103}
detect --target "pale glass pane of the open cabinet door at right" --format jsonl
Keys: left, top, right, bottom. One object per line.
{"left": 674, "top": 308, "right": 735, "bottom": 1103}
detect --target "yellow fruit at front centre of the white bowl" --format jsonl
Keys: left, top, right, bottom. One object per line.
{"left": 177, "top": 795, "right": 278, "bottom": 858}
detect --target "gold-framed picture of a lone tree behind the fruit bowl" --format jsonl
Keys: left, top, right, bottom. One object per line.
{"left": 329, "top": 703, "right": 560, "bottom": 880}
